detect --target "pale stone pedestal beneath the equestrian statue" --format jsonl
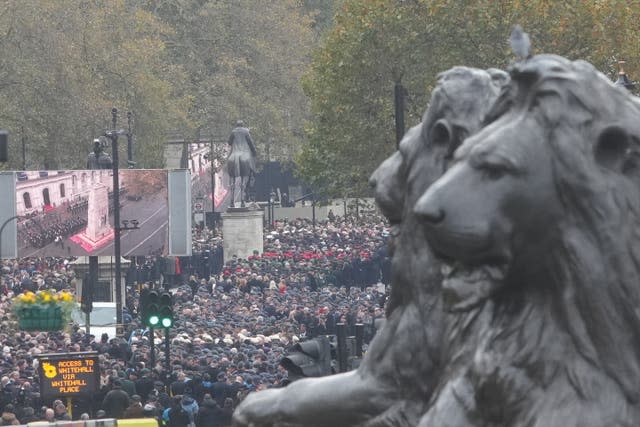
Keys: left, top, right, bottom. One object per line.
{"left": 222, "top": 208, "right": 264, "bottom": 263}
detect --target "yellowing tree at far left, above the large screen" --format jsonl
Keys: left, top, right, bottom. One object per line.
{"left": 0, "top": 0, "right": 189, "bottom": 169}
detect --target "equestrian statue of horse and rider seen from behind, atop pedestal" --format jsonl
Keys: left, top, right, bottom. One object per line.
{"left": 227, "top": 120, "right": 257, "bottom": 208}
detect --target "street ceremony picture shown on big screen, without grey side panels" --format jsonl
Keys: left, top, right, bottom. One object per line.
{"left": 16, "top": 169, "right": 169, "bottom": 257}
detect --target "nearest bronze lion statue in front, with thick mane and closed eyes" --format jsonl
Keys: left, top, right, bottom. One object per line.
{"left": 415, "top": 55, "right": 640, "bottom": 427}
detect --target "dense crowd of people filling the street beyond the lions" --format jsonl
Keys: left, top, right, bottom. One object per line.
{"left": 0, "top": 210, "right": 390, "bottom": 427}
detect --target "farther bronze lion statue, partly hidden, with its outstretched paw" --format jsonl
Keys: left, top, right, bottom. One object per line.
{"left": 234, "top": 67, "right": 508, "bottom": 427}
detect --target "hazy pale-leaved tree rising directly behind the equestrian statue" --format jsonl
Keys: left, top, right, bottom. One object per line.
{"left": 145, "top": 0, "right": 315, "bottom": 164}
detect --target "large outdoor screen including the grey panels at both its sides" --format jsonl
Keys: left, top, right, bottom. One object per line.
{"left": 0, "top": 169, "right": 191, "bottom": 258}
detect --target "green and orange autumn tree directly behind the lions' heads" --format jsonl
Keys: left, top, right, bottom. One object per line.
{"left": 296, "top": 0, "right": 640, "bottom": 195}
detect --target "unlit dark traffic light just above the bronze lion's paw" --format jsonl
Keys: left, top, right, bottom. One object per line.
{"left": 280, "top": 336, "right": 333, "bottom": 381}
